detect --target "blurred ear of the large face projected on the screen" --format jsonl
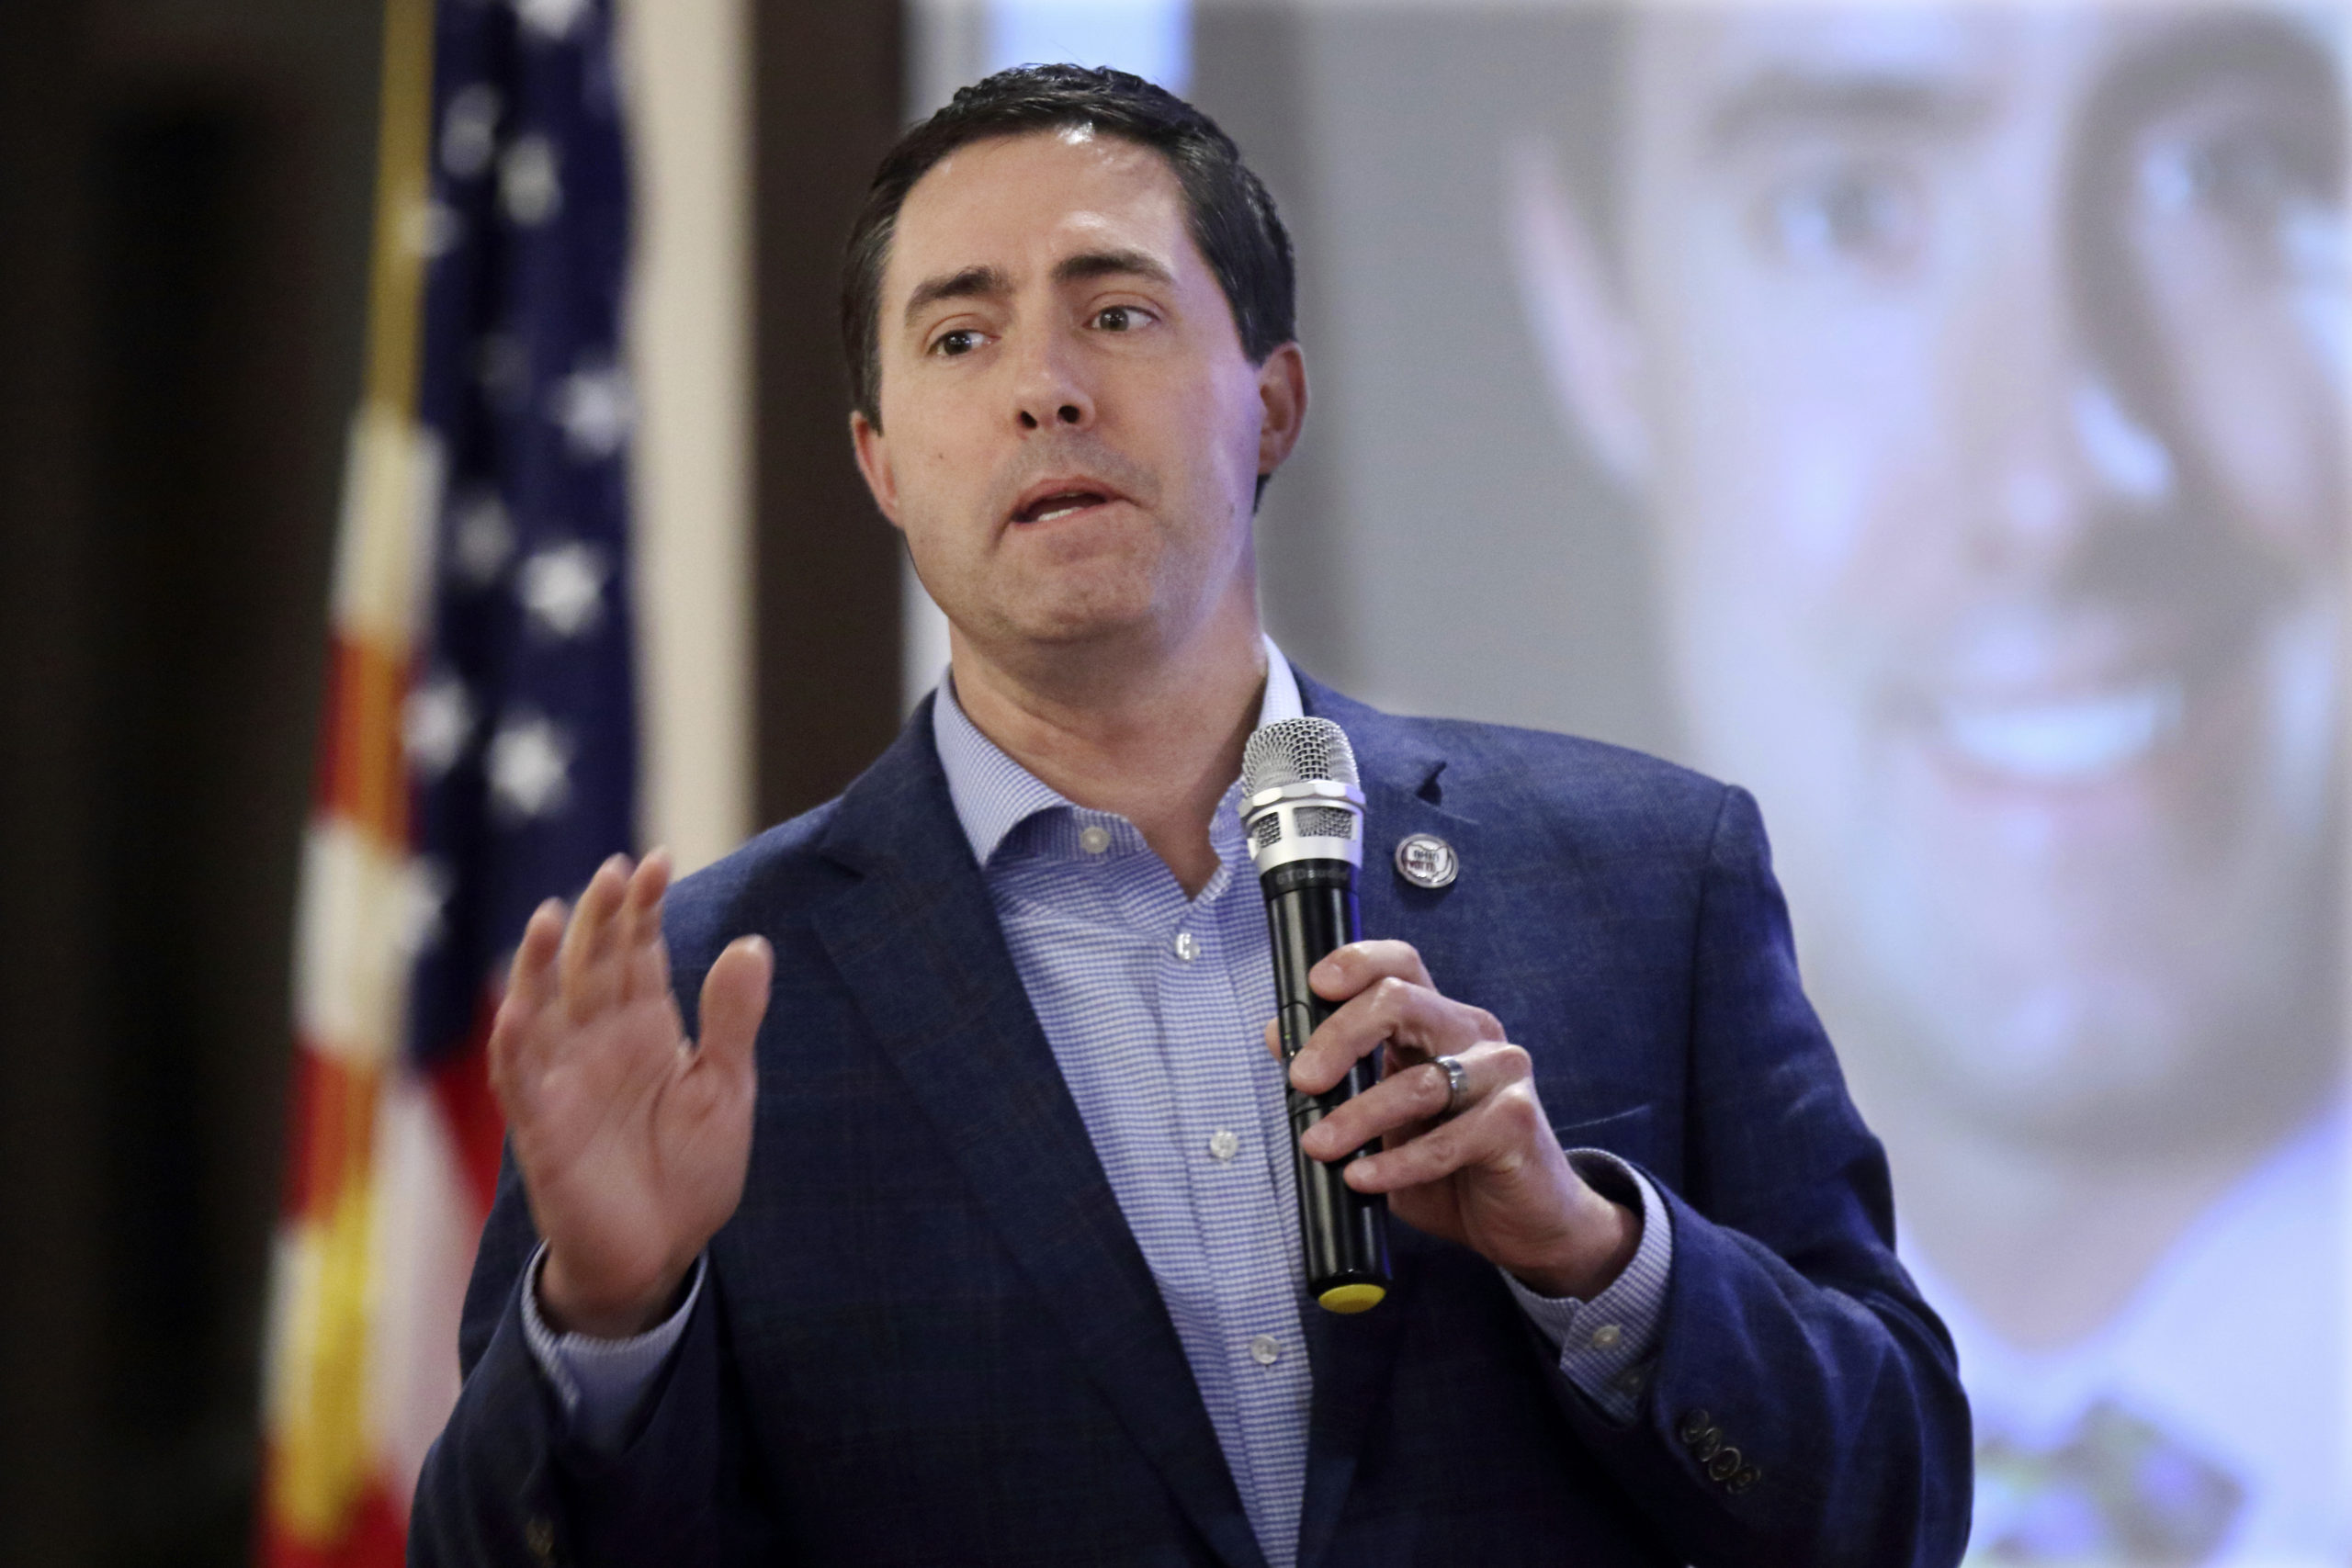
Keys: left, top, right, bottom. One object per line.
{"left": 1503, "top": 136, "right": 1651, "bottom": 491}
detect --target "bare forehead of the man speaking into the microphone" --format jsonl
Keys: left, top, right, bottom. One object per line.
{"left": 885, "top": 127, "right": 1193, "bottom": 301}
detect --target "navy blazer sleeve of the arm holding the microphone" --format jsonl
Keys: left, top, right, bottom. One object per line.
{"left": 1553, "top": 790, "right": 1971, "bottom": 1568}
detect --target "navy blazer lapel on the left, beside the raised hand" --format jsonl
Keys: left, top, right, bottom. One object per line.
{"left": 816, "top": 705, "right": 1265, "bottom": 1568}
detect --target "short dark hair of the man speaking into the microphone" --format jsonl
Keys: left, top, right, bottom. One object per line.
{"left": 842, "top": 66, "right": 1298, "bottom": 428}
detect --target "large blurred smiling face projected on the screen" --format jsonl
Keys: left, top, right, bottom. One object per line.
{"left": 1585, "top": 7, "right": 2345, "bottom": 1145}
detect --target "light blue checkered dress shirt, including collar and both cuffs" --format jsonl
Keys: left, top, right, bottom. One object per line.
{"left": 525, "top": 642, "right": 1672, "bottom": 1568}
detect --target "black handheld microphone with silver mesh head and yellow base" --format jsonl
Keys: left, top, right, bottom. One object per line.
{"left": 1242, "top": 719, "right": 1390, "bottom": 1312}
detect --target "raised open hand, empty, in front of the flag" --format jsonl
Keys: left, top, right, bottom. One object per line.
{"left": 489, "top": 849, "right": 774, "bottom": 1337}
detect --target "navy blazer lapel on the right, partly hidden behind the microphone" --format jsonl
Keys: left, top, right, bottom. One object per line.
{"left": 1298, "top": 674, "right": 1463, "bottom": 1568}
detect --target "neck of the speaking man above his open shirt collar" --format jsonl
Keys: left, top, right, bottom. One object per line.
{"left": 953, "top": 602, "right": 1265, "bottom": 898}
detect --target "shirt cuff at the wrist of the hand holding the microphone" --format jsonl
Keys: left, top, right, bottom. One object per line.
{"left": 1503, "top": 1149, "right": 1675, "bottom": 1422}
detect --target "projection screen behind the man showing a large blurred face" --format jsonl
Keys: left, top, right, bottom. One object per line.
{"left": 910, "top": 0, "right": 2352, "bottom": 1568}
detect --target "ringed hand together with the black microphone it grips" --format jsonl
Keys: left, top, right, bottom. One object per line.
{"left": 1242, "top": 719, "right": 1642, "bottom": 1309}
